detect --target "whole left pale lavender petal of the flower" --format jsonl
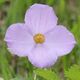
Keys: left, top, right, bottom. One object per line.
{"left": 5, "top": 23, "right": 34, "bottom": 56}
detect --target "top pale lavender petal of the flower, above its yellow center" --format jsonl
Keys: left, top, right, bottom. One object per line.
{"left": 25, "top": 4, "right": 57, "bottom": 33}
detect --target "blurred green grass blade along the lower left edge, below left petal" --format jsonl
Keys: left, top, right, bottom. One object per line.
{"left": 0, "top": 43, "right": 12, "bottom": 80}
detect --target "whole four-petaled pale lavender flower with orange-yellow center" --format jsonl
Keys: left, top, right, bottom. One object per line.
{"left": 5, "top": 4, "right": 76, "bottom": 68}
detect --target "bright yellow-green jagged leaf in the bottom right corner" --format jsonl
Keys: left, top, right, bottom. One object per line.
{"left": 65, "top": 65, "right": 80, "bottom": 80}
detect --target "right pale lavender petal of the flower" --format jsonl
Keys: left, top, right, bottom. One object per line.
{"left": 45, "top": 25, "right": 76, "bottom": 56}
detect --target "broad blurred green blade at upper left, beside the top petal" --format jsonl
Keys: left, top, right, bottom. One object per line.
{"left": 6, "top": 0, "right": 27, "bottom": 26}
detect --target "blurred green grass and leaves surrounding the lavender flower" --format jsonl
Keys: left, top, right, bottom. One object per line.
{"left": 0, "top": 0, "right": 80, "bottom": 80}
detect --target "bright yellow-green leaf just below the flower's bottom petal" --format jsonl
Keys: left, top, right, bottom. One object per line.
{"left": 35, "top": 69, "right": 59, "bottom": 80}
